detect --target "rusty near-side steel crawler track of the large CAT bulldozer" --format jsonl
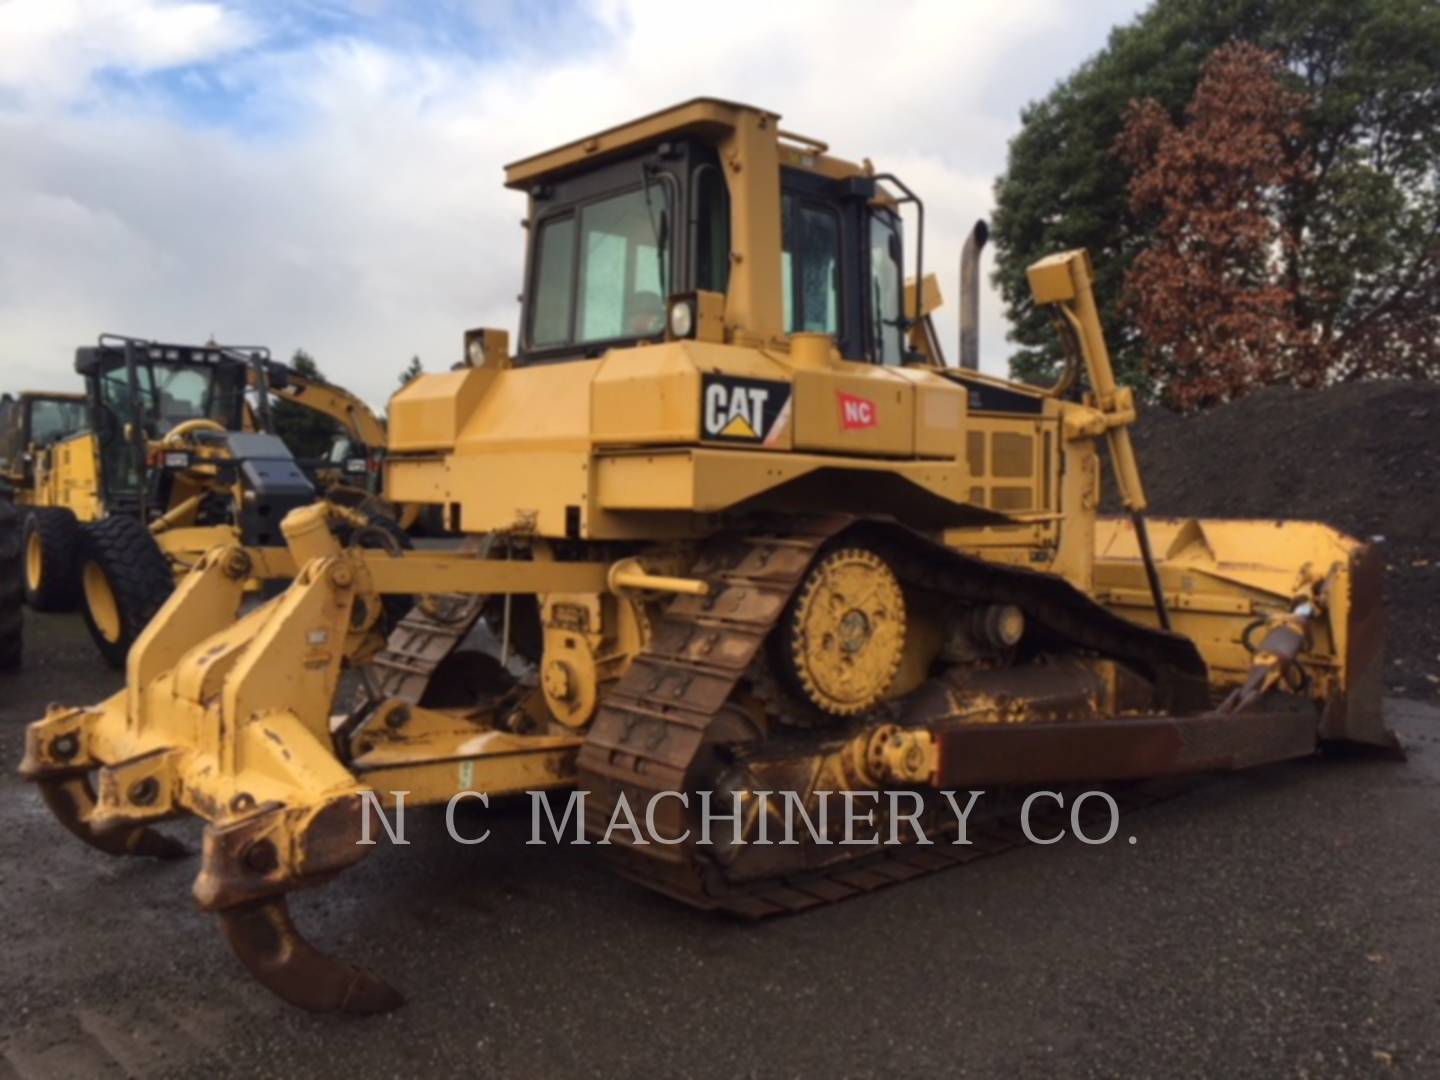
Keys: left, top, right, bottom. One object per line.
{"left": 577, "top": 517, "right": 1205, "bottom": 917}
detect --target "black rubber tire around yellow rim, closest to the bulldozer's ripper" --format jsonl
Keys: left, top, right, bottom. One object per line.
{"left": 76, "top": 514, "right": 174, "bottom": 670}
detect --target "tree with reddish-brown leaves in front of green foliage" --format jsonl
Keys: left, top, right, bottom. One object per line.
{"left": 1115, "top": 43, "right": 1325, "bottom": 409}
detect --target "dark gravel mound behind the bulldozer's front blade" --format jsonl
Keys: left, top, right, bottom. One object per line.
{"left": 1135, "top": 380, "right": 1440, "bottom": 698}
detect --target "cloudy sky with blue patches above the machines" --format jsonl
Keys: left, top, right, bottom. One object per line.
{"left": 0, "top": 0, "right": 1143, "bottom": 406}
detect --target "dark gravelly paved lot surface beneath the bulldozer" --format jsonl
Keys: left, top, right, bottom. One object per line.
{"left": 0, "top": 615, "right": 1440, "bottom": 1077}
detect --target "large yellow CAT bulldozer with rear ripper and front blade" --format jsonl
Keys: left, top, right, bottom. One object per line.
{"left": 22, "top": 99, "right": 1398, "bottom": 1012}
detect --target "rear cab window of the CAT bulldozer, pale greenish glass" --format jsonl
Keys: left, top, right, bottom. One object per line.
{"left": 528, "top": 177, "right": 672, "bottom": 350}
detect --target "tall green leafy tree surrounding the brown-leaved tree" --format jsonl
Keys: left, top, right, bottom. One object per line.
{"left": 994, "top": 0, "right": 1440, "bottom": 393}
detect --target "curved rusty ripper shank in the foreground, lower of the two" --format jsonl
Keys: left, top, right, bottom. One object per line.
{"left": 217, "top": 896, "right": 405, "bottom": 1015}
